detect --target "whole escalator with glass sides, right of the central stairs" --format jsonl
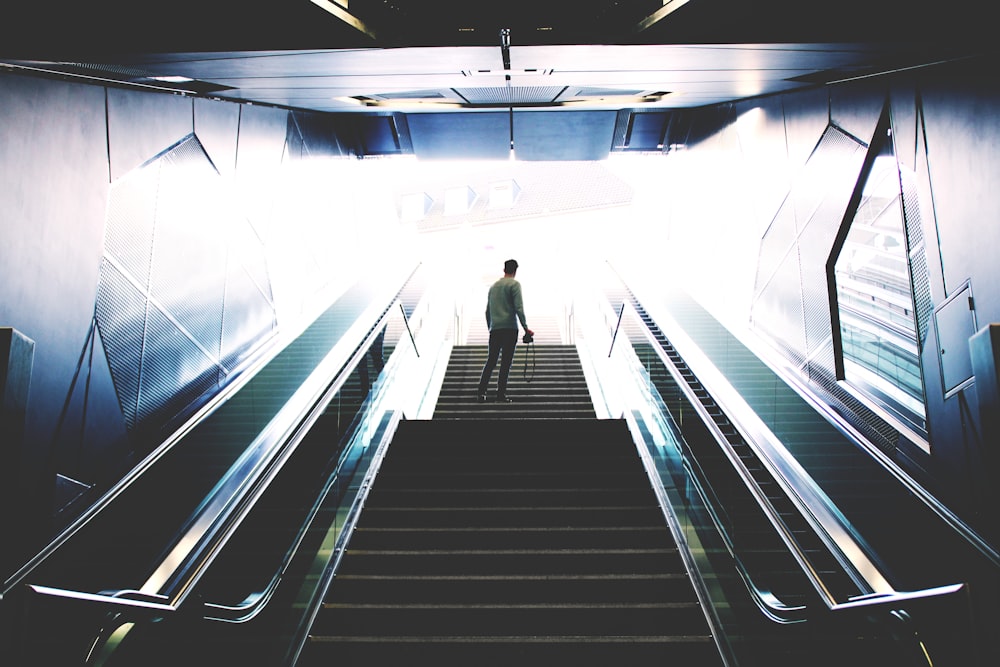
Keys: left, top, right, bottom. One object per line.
{"left": 608, "top": 270, "right": 998, "bottom": 665}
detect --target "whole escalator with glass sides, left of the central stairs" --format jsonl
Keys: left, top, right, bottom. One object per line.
{"left": 2, "top": 264, "right": 421, "bottom": 665}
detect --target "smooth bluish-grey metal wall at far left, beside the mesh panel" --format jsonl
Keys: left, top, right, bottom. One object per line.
{"left": 0, "top": 76, "right": 119, "bottom": 568}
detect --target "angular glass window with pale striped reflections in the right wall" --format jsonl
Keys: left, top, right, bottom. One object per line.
{"left": 835, "top": 142, "right": 925, "bottom": 432}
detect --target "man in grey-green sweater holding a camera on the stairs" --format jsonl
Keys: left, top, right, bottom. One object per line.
{"left": 478, "top": 259, "right": 535, "bottom": 403}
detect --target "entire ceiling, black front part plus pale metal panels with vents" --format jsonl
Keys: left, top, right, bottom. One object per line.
{"left": 0, "top": 0, "right": 991, "bottom": 113}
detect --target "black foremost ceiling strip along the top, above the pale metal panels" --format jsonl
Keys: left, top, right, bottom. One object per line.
{"left": 0, "top": 0, "right": 993, "bottom": 58}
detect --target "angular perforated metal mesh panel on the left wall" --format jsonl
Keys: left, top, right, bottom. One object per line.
{"left": 97, "top": 136, "right": 276, "bottom": 429}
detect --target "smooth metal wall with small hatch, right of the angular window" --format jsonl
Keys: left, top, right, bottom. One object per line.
{"left": 891, "top": 64, "right": 1000, "bottom": 530}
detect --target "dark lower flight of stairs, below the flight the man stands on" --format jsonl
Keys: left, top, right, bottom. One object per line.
{"left": 297, "top": 420, "right": 722, "bottom": 667}
